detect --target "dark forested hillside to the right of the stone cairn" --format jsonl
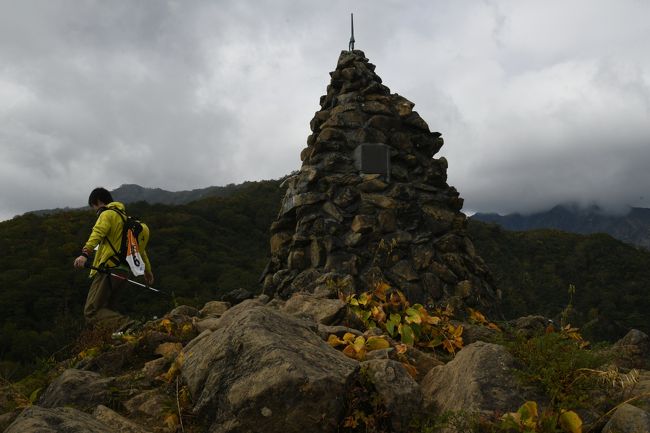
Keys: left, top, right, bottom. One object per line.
{"left": 470, "top": 220, "right": 650, "bottom": 340}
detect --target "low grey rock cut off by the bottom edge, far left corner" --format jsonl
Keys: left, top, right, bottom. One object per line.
{"left": 5, "top": 406, "right": 115, "bottom": 433}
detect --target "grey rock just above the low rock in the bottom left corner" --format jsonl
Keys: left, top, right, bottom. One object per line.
{"left": 39, "top": 369, "right": 114, "bottom": 409}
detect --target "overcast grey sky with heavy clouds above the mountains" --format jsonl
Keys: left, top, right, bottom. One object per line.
{"left": 0, "top": 0, "right": 650, "bottom": 219}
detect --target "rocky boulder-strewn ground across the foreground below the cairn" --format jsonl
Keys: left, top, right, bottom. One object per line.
{"left": 0, "top": 287, "right": 650, "bottom": 433}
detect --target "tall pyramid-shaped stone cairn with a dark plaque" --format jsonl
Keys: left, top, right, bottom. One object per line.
{"left": 262, "top": 50, "right": 496, "bottom": 310}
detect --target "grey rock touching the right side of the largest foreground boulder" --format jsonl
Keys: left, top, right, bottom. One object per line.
{"left": 361, "top": 359, "right": 422, "bottom": 433}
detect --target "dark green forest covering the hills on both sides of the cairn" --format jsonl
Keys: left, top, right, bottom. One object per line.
{"left": 0, "top": 180, "right": 650, "bottom": 380}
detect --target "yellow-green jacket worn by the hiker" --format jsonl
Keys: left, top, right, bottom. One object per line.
{"left": 82, "top": 201, "right": 151, "bottom": 277}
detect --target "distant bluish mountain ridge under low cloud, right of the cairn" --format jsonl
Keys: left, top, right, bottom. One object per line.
{"left": 472, "top": 205, "right": 650, "bottom": 249}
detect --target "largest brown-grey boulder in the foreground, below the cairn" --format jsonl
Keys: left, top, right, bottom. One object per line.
{"left": 181, "top": 300, "right": 359, "bottom": 433}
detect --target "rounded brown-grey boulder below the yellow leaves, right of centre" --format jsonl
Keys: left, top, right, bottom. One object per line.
{"left": 420, "top": 341, "right": 527, "bottom": 414}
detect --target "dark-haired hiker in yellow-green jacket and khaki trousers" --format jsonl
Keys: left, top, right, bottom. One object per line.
{"left": 74, "top": 188, "right": 154, "bottom": 329}
